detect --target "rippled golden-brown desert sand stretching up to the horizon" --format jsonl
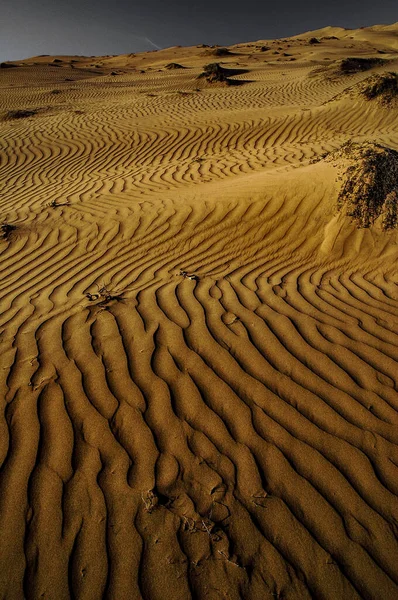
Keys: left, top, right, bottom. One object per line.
{"left": 0, "top": 27, "right": 398, "bottom": 600}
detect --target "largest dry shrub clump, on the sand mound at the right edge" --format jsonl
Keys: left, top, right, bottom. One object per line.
{"left": 327, "top": 141, "right": 398, "bottom": 231}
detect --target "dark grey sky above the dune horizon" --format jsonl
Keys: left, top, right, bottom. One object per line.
{"left": 0, "top": 0, "right": 398, "bottom": 61}
